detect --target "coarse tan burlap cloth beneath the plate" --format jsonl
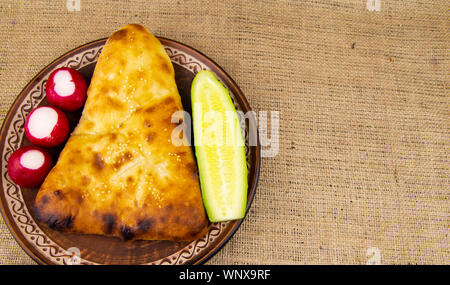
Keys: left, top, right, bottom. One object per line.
{"left": 0, "top": 0, "right": 450, "bottom": 264}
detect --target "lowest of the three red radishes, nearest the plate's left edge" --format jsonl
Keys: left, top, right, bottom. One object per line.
{"left": 8, "top": 145, "right": 52, "bottom": 188}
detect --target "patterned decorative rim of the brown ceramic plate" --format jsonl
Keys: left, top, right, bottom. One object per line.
{"left": 0, "top": 37, "right": 261, "bottom": 265}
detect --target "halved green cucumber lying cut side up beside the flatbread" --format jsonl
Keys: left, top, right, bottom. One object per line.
{"left": 191, "top": 70, "right": 248, "bottom": 222}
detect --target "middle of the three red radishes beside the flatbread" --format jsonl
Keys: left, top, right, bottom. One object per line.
{"left": 25, "top": 106, "right": 69, "bottom": 147}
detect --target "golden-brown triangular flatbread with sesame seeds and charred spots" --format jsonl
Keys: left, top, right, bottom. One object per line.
{"left": 35, "top": 24, "right": 208, "bottom": 240}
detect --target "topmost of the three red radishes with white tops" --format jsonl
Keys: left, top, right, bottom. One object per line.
{"left": 45, "top": 67, "right": 87, "bottom": 111}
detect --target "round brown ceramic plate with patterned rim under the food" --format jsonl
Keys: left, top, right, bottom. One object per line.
{"left": 0, "top": 38, "right": 261, "bottom": 264}
